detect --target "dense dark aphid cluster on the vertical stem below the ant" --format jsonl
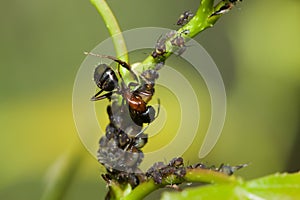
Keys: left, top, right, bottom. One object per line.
{"left": 98, "top": 104, "right": 148, "bottom": 188}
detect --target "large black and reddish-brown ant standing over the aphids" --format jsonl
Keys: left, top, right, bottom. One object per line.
{"left": 85, "top": 52, "right": 160, "bottom": 126}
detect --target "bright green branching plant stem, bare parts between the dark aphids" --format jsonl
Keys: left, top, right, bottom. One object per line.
{"left": 91, "top": 0, "right": 238, "bottom": 200}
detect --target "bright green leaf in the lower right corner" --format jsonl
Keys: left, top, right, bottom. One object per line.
{"left": 162, "top": 173, "right": 300, "bottom": 200}
